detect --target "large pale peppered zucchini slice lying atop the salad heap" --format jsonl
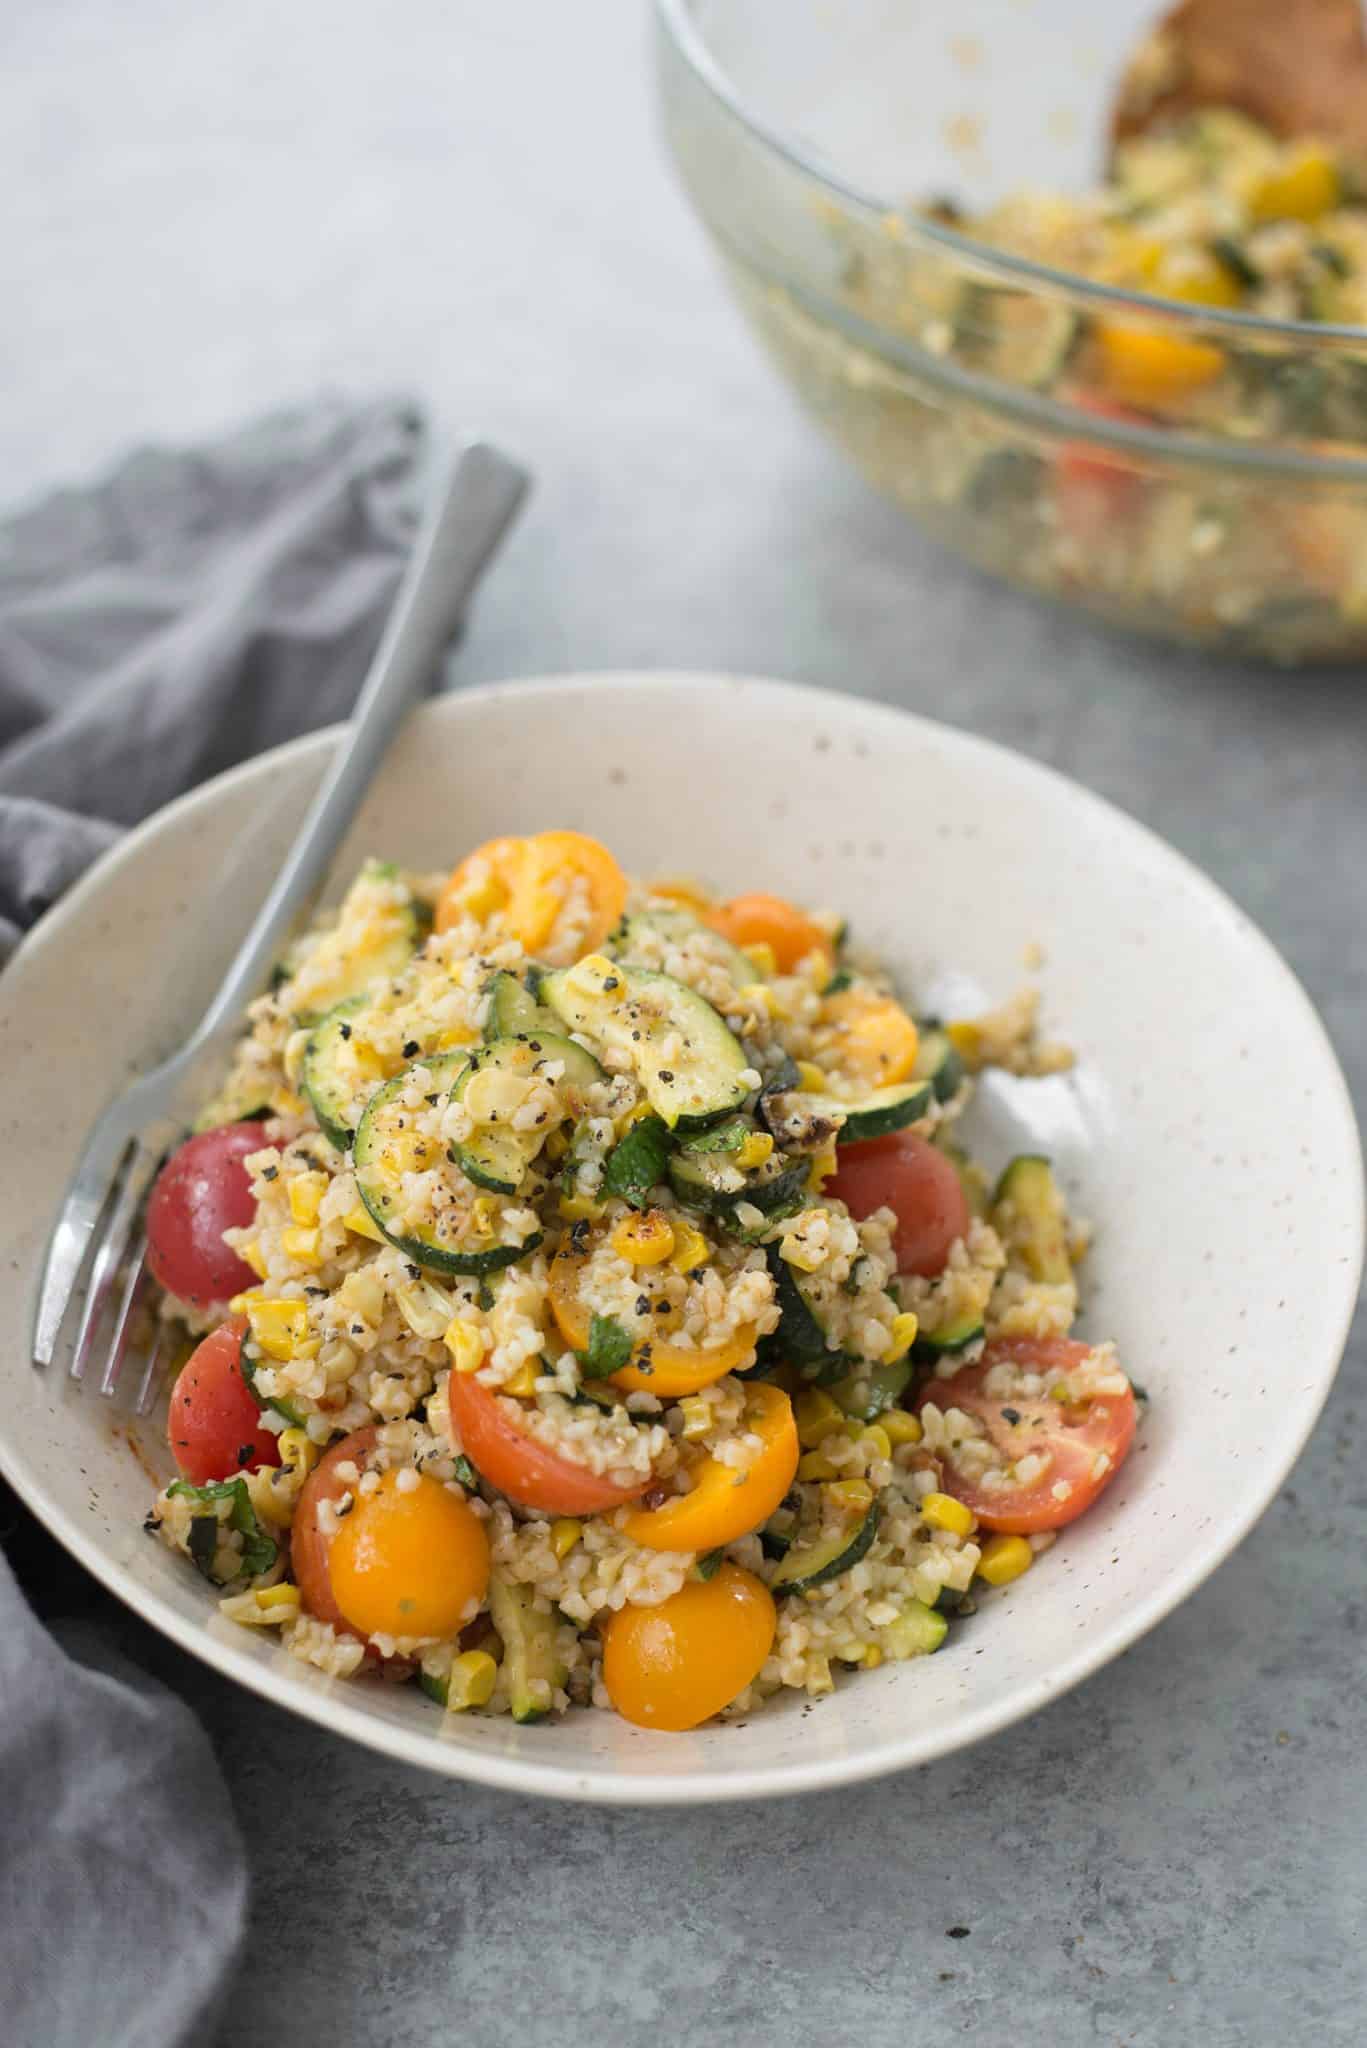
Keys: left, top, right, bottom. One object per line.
{"left": 537, "top": 952, "right": 750, "bottom": 1130}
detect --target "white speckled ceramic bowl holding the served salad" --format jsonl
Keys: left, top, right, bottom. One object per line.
{"left": 0, "top": 676, "right": 1363, "bottom": 1802}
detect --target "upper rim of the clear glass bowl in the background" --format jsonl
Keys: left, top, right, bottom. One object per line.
{"left": 656, "top": 0, "right": 1367, "bottom": 348}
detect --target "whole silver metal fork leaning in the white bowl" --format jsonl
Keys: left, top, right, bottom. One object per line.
{"left": 33, "top": 442, "right": 529, "bottom": 1415}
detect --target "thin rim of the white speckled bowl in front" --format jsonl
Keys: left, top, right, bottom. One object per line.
{"left": 0, "top": 670, "right": 1367, "bottom": 1806}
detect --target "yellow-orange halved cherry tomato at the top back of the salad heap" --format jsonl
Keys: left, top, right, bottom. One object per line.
{"left": 437, "top": 831, "right": 627, "bottom": 956}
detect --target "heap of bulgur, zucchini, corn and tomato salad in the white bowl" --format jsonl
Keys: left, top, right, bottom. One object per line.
{"left": 148, "top": 831, "right": 1135, "bottom": 1729}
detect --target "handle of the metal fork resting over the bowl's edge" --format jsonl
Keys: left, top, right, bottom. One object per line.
{"left": 181, "top": 440, "right": 529, "bottom": 1049}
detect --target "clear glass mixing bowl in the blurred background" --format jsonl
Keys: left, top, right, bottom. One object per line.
{"left": 656, "top": 0, "right": 1367, "bottom": 664}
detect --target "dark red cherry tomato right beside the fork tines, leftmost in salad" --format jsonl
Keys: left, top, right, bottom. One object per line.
{"left": 148, "top": 1124, "right": 266, "bottom": 1309}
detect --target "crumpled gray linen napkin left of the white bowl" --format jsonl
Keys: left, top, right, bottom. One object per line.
{"left": 0, "top": 401, "right": 422, "bottom": 2048}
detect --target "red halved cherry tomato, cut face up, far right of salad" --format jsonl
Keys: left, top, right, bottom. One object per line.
{"left": 916, "top": 1337, "right": 1135, "bottom": 1536}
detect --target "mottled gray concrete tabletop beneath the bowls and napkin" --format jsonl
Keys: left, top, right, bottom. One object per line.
{"left": 0, "top": 0, "right": 1367, "bottom": 2048}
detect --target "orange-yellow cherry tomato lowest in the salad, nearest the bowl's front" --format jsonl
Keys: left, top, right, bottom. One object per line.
{"left": 603, "top": 1565, "right": 775, "bottom": 1731}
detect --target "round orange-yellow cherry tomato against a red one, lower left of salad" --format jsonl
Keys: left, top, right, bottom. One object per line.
{"left": 328, "top": 1470, "right": 490, "bottom": 1636}
